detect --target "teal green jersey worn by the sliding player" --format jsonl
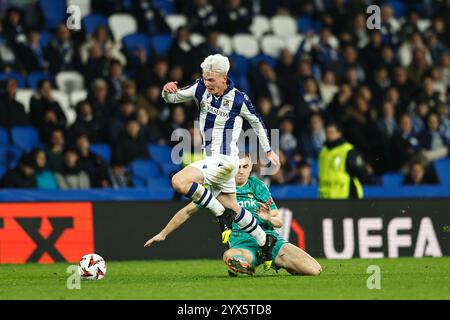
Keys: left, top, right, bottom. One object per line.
{"left": 233, "top": 177, "right": 277, "bottom": 231}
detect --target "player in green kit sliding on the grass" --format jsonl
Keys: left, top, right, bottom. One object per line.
{"left": 145, "top": 155, "right": 322, "bottom": 276}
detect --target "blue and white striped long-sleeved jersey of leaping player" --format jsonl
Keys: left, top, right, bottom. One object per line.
{"left": 162, "top": 79, "right": 271, "bottom": 156}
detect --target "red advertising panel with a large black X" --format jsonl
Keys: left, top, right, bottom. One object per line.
{"left": 0, "top": 202, "right": 94, "bottom": 263}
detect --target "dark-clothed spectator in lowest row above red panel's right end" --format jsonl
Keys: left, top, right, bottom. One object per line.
{"left": 75, "top": 134, "right": 111, "bottom": 188}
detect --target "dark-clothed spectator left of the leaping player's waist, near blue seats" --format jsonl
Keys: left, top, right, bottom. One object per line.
{"left": 113, "top": 120, "right": 150, "bottom": 165}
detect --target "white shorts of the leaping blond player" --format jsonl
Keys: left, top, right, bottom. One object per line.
{"left": 189, "top": 154, "right": 239, "bottom": 197}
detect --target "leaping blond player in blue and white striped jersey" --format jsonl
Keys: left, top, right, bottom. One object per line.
{"left": 162, "top": 54, "right": 279, "bottom": 269}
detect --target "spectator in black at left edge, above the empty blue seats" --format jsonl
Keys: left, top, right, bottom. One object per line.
{"left": 0, "top": 79, "right": 29, "bottom": 130}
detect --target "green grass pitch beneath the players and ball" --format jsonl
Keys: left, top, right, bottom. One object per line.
{"left": 0, "top": 257, "right": 450, "bottom": 300}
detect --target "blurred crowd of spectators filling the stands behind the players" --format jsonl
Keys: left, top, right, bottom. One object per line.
{"left": 0, "top": 0, "right": 450, "bottom": 188}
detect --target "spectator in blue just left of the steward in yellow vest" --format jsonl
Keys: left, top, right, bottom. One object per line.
{"left": 301, "top": 113, "right": 325, "bottom": 162}
